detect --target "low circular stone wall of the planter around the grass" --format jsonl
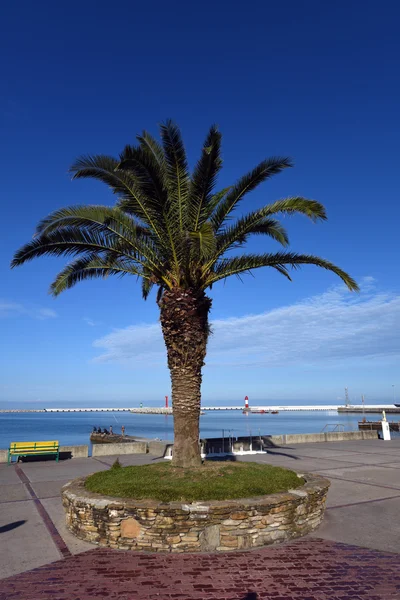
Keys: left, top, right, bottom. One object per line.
{"left": 62, "top": 474, "right": 330, "bottom": 552}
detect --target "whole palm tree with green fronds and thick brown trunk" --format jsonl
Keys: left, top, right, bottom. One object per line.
{"left": 11, "top": 121, "right": 358, "bottom": 467}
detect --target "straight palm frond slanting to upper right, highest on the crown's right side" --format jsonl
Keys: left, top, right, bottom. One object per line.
{"left": 211, "top": 156, "right": 292, "bottom": 231}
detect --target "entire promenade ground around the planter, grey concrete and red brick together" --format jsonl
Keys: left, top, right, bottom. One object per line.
{"left": 0, "top": 438, "right": 400, "bottom": 600}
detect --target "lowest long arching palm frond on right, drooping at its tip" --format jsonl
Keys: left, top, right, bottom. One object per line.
{"left": 205, "top": 252, "right": 359, "bottom": 291}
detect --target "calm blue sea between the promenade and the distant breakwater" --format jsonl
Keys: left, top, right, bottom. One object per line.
{"left": 0, "top": 410, "right": 398, "bottom": 448}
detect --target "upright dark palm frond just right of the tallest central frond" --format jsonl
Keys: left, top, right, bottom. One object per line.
{"left": 188, "top": 125, "right": 222, "bottom": 231}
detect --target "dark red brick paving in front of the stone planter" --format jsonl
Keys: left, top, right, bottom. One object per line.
{"left": 0, "top": 538, "right": 400, "bottom": 600}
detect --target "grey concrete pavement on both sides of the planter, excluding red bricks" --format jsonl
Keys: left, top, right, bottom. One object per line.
{"left": 0, "top": 438, "right": 400, "bottom": 577}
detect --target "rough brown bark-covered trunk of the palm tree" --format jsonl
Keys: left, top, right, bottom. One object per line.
{"left": 159, "top": 289, "right": 211, "bottom": 467}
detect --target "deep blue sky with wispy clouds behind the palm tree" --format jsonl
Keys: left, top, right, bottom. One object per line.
{"left": 0, "top": 0, "right": 400, "bottom": 406}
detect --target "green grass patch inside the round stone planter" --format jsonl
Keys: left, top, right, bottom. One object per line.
{"left": 85, "top": 461, "right": 304, "bottom": 502}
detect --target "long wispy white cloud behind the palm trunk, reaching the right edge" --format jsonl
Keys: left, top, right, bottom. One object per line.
{"left": 94, "top": 277, "right": 400, "bottom": 368}
